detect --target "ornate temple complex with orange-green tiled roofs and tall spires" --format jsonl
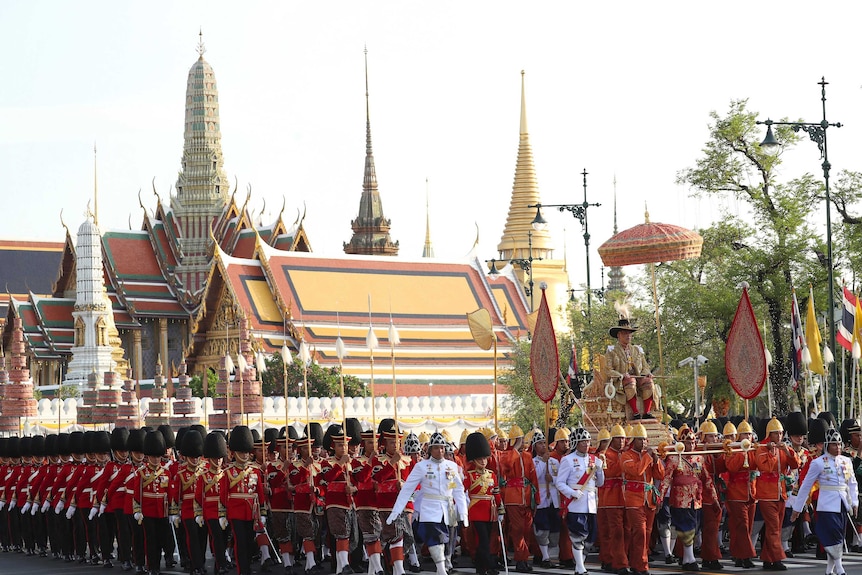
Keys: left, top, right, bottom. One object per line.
{"left": 0, "top": 43, "right": 568, "bottom": 395}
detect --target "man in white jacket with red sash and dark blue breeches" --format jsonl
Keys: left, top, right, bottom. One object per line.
{"left": 554, "top": 428, "right": 605, "bottom": 575}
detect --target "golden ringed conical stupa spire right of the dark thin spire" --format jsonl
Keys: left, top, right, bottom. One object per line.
{"left": 497, "top": 70, "right": 553, "bottom": 260}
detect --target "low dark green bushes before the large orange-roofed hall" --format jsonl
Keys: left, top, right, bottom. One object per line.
{"left": 261, "top": 354, "right": 363, "bottom": 397}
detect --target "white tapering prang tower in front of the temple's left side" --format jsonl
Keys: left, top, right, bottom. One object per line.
{"left": 63, "top": 215, "right": 119, "bottom": 388}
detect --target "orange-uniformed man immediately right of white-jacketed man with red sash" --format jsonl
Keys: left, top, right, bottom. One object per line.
{"left": 597, "top": 424, "right": 629, "bottom": 575}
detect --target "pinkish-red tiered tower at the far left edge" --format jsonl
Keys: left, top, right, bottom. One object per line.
{"left": 0, "top": 317, "right": 36, "bottom": 433}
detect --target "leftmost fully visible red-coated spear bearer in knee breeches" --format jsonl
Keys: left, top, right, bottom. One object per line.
{"left": 288, "top": 422, "right": 324, "bottom": 573}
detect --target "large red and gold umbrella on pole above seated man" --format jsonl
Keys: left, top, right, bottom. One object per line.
{"left": 599, "top": 208, "right": 703, "bottom": 375}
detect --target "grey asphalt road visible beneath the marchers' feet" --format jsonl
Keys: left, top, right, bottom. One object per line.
{"left": 0, "top": 552, "right": 862, "bottom": 575}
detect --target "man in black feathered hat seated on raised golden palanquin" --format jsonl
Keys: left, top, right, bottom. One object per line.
{"left": 605, "top": 318, "right": 653, "bottom": 419}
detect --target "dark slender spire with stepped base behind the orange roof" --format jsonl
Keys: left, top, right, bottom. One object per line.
{"left": 344, "top": 48, "right": 398, "bottom": 256}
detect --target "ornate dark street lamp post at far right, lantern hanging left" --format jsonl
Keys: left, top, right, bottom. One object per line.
{"left": 757, "top": 77, "right": 841, "bottom": 413}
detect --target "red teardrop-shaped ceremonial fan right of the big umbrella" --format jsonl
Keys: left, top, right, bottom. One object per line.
{"left": 724, "top": 285, "right": 766, "bottom": 399}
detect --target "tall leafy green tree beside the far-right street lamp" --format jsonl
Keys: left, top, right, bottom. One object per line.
{"left": 675, "top": 100, "right": 825, "bottom": 415}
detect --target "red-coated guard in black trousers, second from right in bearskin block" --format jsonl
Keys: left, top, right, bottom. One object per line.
{"left": 195, "top": 431, "right": 229, "bottom": 575}
